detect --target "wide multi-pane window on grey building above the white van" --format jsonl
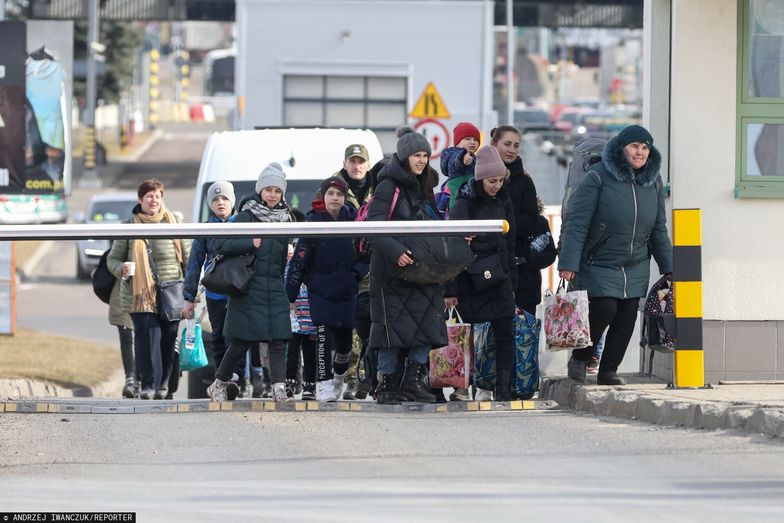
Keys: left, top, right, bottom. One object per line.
{"left": 283, "top": 75, "right": 408, "bottom": 151}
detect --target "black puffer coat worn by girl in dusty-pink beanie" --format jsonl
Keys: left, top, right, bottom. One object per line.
{"left": 444, "top": 178, "right": 517, "bottom": 323}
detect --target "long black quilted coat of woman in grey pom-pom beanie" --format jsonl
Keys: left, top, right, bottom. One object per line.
{"left": 367, "top": 154, "right": 447, "bottom": 348}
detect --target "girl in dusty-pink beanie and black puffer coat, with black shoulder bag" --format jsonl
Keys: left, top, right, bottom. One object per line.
{"left": 446, "top": 145, "right": 517, "bottom": 401}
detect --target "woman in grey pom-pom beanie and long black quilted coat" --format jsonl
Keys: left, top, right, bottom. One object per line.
{"left": 367, "top": 132, "right": 447, "bottom": 404}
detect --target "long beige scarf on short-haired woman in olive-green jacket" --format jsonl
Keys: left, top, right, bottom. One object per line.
{"left": 129, "top": 206, "right": 182, "bottom": 312}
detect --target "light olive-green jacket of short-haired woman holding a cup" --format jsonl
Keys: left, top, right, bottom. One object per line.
{"left": 106, "top": 205, "right": 191, "bottom": 314}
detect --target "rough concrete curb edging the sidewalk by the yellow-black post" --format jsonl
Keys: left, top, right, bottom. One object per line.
{"left": 539, "top": 378, "right": 784, "bottom": 437}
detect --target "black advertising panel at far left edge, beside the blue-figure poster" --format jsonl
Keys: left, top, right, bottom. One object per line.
{"left": 0, "top": 21, "right": 27, "bottom": 192}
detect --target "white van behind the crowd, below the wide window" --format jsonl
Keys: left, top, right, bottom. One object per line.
{"left": 193, "top": 128, "right": 383, "bottom": 223}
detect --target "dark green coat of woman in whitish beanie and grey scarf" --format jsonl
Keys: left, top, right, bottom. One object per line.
{"left": 213, "top": 195, "right": 291, "bottom": 341}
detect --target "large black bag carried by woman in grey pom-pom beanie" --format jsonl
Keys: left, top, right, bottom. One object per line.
{"left": 394, "top": 236, "right": 474, "bottom": 285}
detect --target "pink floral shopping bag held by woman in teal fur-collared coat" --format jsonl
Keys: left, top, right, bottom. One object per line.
{"left": 542, "top": 280, "right": 591, "bottom": 351}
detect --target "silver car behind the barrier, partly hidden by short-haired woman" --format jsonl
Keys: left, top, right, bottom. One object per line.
{"left": 73, "top": 192, "right": 138, "bottom": 280}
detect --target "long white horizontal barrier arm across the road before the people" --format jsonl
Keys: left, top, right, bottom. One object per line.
{"left": 0, "top": 220, "right": 509, "bottom": 241}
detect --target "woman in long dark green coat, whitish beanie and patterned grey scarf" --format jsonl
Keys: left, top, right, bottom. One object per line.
{"left": 207, "top": 162, "right": 292, "bottom": 401}
